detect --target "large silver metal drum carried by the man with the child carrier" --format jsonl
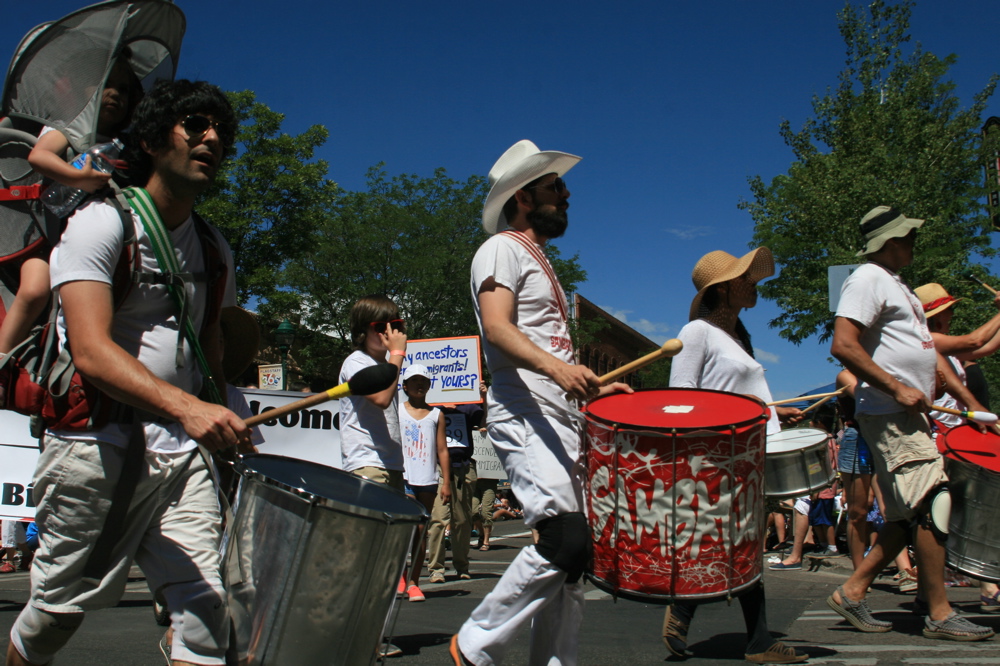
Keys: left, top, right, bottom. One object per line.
{"left": 224, "top": 455, "right": 427, "bottom": 665}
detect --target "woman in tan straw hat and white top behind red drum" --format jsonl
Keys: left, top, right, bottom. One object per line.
{"left": 663, "top": 247, "right": 808, "bottom": 664}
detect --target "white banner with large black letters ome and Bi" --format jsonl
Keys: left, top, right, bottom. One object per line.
{"left": 0, "top": 389, "right": 343, "bottom": 518}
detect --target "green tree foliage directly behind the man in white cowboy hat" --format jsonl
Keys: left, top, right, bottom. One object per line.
{"left": 274, "top": 164, "right": 586, "bottom": 379}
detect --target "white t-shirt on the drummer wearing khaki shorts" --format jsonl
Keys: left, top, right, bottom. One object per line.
{"left": 837, "top": 263, "right": 937, "bottom": 414}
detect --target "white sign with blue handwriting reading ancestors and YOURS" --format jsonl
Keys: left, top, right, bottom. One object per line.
{"left": 399, "top": 335, "right": 483, "bottom": 405}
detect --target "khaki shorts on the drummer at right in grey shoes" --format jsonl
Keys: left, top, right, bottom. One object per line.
{"left": 857, "top": 412, "right": 948, "bottom": 522}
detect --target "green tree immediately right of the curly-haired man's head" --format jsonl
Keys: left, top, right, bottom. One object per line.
{"left": 197, "top": 90, "right": 337, "bottom": 304}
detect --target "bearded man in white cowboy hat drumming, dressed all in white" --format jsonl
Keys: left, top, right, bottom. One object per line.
{"left": 451, "top": 141, "right": 631, "bottom": 666}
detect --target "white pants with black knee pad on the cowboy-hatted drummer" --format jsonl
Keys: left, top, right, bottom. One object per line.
{"left": 458, "top": 414, "right": 586, "bottom": 666}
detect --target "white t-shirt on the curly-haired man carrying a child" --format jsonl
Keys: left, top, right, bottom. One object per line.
{"left": 49, "top": 201, "right": 236, "bottom": 453}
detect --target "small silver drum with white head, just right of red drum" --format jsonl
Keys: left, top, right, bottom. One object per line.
{"left": 764, "top": 428, "right": 837, "bottom": 497}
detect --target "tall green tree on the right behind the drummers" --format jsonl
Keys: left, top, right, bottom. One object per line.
{"left": 740, "top": 0, "right": 997, "bottom": 343}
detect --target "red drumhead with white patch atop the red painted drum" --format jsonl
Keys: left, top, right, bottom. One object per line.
{"left": 584, "top": 389, "right": 767, "bottom": 431}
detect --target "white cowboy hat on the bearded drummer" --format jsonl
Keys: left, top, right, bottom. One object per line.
{"left": 483, "top": 139, "right": 581, "bottom": 234}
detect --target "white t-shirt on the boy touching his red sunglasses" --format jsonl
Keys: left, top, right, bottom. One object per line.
{"left": 340, "top": 350, "right": 403, "bottom": 472}
